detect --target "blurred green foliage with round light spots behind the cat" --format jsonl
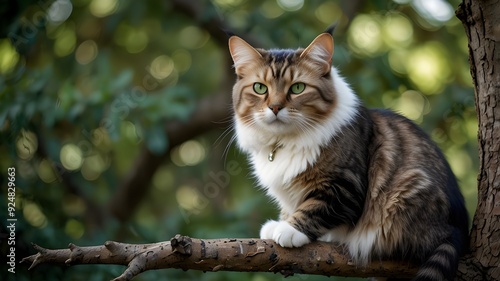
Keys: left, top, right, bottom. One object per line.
{"left": 0, "top": 0, "right": 478, "bottom": 281}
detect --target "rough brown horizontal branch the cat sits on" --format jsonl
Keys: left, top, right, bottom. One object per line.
{"left": 21, "top": 235, "right": 417, "bottom": 281}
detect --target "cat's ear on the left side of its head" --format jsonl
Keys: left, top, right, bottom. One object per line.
{"left": 229, "top": 36, "right": 262, "bottom": 75}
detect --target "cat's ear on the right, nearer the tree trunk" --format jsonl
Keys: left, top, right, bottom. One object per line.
{"left": 300, "top": 33, "right": 333, "bottom": 73}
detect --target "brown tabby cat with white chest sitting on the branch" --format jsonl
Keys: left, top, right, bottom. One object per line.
{"left": 228, "top": 29, "right": 469, "bottom": 280}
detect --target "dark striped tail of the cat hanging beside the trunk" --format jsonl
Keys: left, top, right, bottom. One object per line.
{"left": 412, "top": 229, "right": 466, "bottom": 281}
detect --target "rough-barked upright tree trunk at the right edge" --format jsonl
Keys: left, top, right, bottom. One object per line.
{"left": 457, "top": 0, "right": 500, "bottom": 281}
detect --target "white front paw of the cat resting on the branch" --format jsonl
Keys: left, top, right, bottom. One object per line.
{"left": 260, "top": 221, "right": 311, "bottom": 248}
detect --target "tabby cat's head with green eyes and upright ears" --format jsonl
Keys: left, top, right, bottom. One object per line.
{"left": 229, "top": 33, "right": 336, "bottom": 138}
